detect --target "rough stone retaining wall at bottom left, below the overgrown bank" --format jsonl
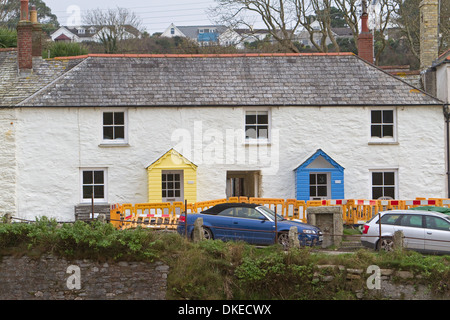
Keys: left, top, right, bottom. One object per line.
{"left": 0, "top": 255, "right": 169, "bottom": 300}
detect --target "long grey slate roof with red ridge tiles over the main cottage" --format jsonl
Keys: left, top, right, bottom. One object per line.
{"left": 12, "top": 53, "right": 443, "bottom": 107}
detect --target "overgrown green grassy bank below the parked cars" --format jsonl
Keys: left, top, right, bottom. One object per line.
{"left": 0, "top": 218, "right": 450, "bottom": 300}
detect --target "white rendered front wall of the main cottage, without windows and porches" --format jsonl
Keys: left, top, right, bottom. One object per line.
{"left": 16, "top": 107, "right": 446, "bottom": 221}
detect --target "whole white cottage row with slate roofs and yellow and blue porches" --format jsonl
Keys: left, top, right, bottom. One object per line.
{"left": 0, "top": 4, "right": 447, "bottom": 221}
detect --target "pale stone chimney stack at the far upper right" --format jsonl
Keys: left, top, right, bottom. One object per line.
{"left": 419, "top": 0, "right": 439, "bottom": 70}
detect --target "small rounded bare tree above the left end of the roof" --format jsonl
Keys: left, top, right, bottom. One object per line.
{"left": 84, "top": 8, "right": 141, "bottom": 53}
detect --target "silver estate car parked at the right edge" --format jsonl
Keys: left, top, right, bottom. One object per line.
{"left": 361, "top": 210, "right": 450, "bottom": 254}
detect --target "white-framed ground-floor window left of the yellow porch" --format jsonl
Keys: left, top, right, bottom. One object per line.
{"left": 81, "top": 169, "right": 106, "bottom": 202}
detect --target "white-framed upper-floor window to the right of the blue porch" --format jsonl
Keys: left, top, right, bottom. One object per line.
{"left": 370, "top": 109, "right": 396, "bottom": 141}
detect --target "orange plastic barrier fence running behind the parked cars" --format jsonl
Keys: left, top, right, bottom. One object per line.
{"left": 110, "top": 197, "right": 450, "bottom": 229}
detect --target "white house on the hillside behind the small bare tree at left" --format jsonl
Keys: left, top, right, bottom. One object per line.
{"left": 50, "top": 25, "right": 140, "bottom": 42}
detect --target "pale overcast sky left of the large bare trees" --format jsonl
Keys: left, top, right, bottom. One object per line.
{"left": 44, "top": 0, "right": 223, "bottom": 34}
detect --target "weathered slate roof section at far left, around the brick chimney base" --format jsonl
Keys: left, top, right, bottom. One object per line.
{"left": 0, "top": 49, "right": 68, "bottom": 107}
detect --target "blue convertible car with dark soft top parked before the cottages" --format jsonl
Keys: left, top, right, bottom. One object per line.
{"left": 177, "top": 203, "right": 322, "bottom": 246}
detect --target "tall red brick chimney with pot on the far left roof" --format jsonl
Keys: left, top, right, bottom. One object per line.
{"left": 17, "top": 0, "right": 33, "bottom": 74}
